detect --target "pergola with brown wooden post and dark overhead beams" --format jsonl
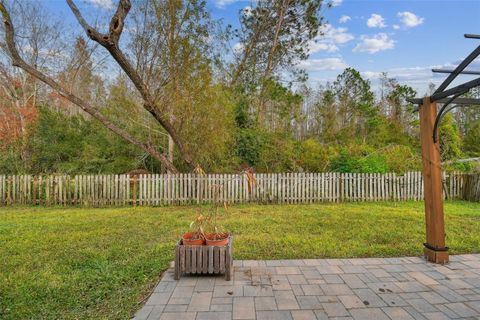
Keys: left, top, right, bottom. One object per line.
{"left": 409, "top": 34, "right": 480, "bottom": 263}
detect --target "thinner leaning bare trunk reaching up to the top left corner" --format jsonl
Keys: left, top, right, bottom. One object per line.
{"left": 0, "top": 0, "right": 178, "bottom": 173}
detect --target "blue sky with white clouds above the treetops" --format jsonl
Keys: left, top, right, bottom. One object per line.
{"left": 46, "top": 0, "right": 480, "bottom": 94}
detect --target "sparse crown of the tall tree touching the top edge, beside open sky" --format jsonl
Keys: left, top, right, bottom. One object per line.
{"left": 233, "top": 0, "right": 323, "bottom": 88}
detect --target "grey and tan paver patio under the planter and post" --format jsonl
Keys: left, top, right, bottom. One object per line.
{"left": 135, "top": 254, "right": 480, "bottom": 320}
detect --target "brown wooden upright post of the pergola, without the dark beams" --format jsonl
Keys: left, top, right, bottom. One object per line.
{"left": 419, "top": 97, "right": 448, "bottom": 264}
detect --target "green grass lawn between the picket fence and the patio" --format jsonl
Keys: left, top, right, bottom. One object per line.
{"left": 0, "top": 202, "right": 480, "bottom": 319}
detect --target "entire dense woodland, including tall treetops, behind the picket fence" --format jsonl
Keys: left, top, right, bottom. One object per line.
{"left": 0, "top": 0, "right": 480, "bottom": 174}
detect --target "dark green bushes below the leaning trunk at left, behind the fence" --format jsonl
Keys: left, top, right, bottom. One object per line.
{"left": 30, "top": 108, "right": 150, "bottom": 173}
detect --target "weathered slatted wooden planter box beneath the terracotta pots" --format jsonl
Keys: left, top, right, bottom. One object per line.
{"left": 174, "top": 236, "right": 233, "bottom": 281}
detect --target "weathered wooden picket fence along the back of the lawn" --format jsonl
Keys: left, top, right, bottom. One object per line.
{"left": 0, "top": 172, "right": 470, "bottom": 207}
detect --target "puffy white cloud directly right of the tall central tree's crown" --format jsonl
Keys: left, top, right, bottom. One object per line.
{"left": 308, "top": 24, "right": 354, "bottom": 53}
